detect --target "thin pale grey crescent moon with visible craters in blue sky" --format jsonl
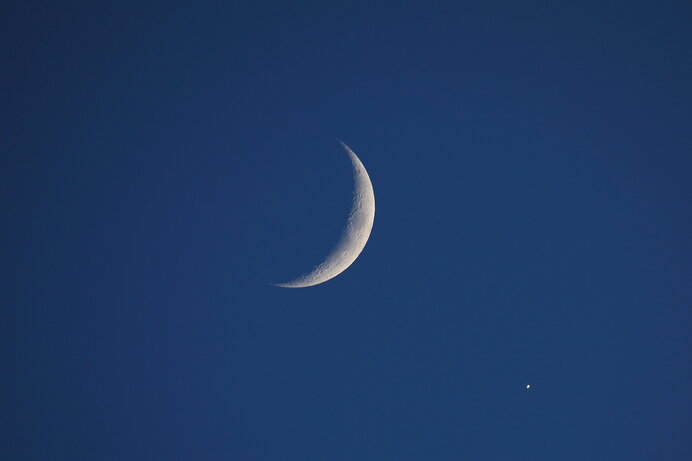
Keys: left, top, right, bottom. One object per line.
{"left": 273, "top": 141, "right": 375, "bottom": 288}
